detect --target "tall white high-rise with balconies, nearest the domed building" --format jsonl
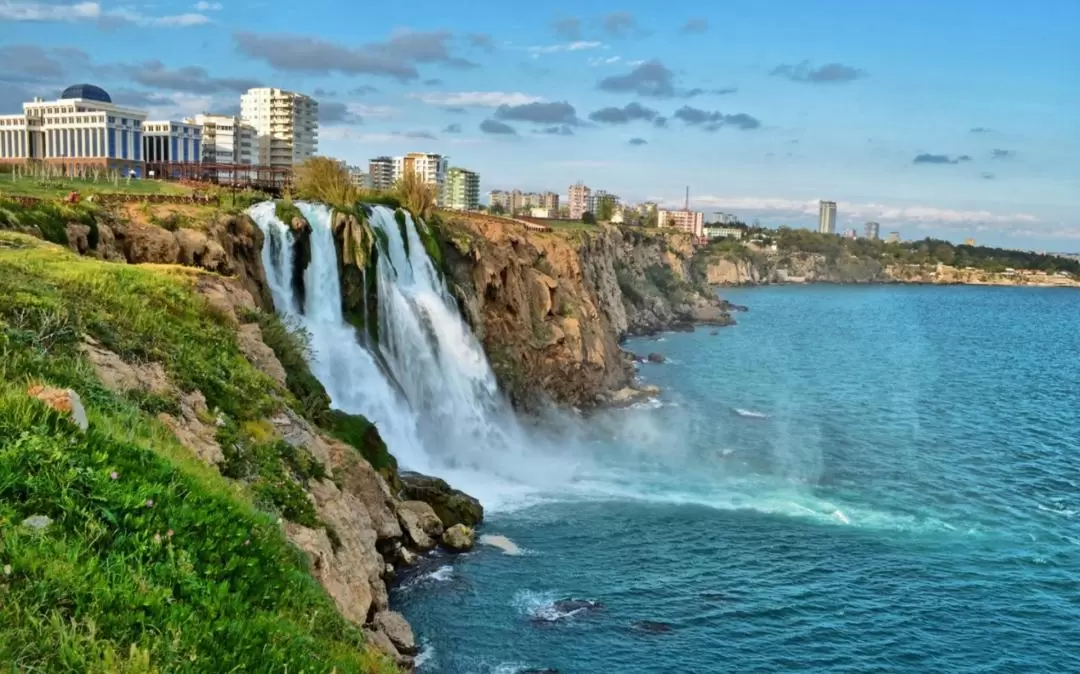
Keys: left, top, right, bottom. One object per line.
{"left": 240, "top": 87, "right": 319, "bottom": 166}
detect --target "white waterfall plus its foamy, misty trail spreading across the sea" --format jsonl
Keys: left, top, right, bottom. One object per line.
{"left": 248, "top": 202, "right": 902, "bottom": 522}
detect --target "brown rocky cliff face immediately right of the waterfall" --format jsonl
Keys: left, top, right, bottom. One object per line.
{"left": 438, "top": 215, "right": 731, "bottom": 408}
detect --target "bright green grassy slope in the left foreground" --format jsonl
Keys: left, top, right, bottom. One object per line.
{"left": 0, "top": 231, "right": 393, "bottom": 673}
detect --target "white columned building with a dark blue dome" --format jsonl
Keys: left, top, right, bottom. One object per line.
{"left": 0, "top": 84, "right": 146, "bottom": 175}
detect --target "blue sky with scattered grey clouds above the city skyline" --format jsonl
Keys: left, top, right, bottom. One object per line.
{"left": 0, "top": 0, "right": 1080, "bottom": 251}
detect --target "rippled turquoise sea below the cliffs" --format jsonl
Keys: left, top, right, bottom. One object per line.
{"left": 393, "top": 286, "right": 1080, "bottom": 674}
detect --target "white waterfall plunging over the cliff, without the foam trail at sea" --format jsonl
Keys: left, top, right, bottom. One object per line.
{"left": 248, "top": 202, "right": 573, "bottom": 508}
